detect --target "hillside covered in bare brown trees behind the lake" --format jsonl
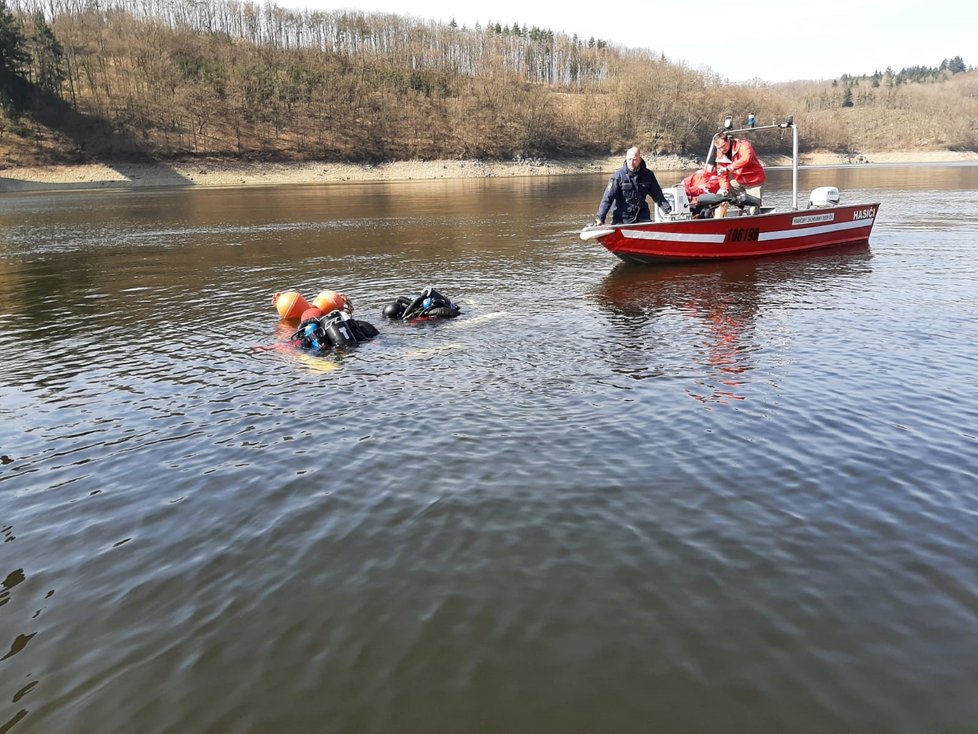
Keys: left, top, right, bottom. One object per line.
{"left": 0, "top": 0, "right": 978, "bottom": 165}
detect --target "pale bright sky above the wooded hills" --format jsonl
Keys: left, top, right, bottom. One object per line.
{"left": 271, "top": 0, "right": 978, "bottom": 82}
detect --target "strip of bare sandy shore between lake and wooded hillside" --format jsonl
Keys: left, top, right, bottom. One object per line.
{"left": 0, "top": 151, "right": 978, "bottom": 193}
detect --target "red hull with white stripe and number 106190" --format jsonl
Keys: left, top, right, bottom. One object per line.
{"left": 581, "top": 204, "right": 879, "bottom": 263}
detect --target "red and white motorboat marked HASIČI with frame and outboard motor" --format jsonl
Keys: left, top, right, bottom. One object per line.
{"left": 581, "top": 117, "right": 879, "bottom": 263}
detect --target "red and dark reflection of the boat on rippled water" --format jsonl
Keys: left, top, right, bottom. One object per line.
{"left": 594, "top": 249, "right": 871, "bottom": 403}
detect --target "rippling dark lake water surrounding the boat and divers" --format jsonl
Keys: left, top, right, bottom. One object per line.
{"left": 0, "top": 165, "right": 978, "bottom": 734}
